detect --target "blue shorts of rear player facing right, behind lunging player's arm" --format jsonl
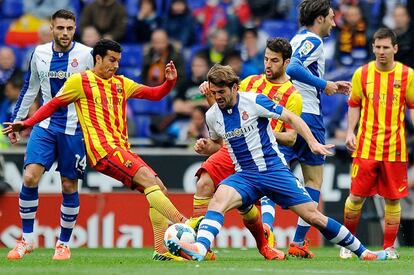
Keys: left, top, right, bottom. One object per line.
{"left": 279, "top": 113, "right": 325, "bottom": 166}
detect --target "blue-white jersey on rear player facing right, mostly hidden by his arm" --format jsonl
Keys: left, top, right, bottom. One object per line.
{"left": 290, "top": 29, "right": 325, "bottom": 115}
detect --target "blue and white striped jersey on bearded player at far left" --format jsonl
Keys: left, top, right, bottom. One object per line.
{"left": 13, "top": 42, "right": 93, "bottom": 135}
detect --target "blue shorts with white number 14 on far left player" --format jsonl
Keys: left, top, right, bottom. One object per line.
{"left": 24, "top": 126, "right": 86, "bottom": 180}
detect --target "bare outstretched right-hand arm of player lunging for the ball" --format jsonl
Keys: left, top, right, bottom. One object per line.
{"left": 279, "top": 108, "right": 335, "bottom": 156}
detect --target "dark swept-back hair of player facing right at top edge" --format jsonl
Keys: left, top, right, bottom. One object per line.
{"left": 299, "top": 0, "right": 331, "bottom": 27}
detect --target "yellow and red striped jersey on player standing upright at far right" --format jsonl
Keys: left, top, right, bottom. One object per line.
{"left": 349, "top": 61, "right": 414, "bottom": 162}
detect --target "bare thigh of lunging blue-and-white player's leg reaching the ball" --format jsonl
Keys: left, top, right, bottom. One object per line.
{"left": 208, "top": 184, "right": 242, "bottom": 213}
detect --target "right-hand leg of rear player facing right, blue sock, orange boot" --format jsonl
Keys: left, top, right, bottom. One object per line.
{"left": 288, "top": 164, "right": 323, "bottom": 258}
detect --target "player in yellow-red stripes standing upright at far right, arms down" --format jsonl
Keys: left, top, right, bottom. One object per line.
{"left": 340, "top": 28, "right": 414, "bottom": 259}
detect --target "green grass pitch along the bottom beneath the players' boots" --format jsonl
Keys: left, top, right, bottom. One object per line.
{"left": 0, "top": 247, "right": 414, "bottom": 275}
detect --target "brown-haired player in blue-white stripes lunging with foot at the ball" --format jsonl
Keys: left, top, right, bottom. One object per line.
{"left": 167, "top": 64, "right": 387, "bottom": 261}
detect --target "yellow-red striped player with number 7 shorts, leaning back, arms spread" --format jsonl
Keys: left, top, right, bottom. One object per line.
{"left": 3, "top": 39, "right": 199, "bottom": 260}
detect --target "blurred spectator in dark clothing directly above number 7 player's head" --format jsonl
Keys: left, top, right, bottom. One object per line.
{"left": 80, "top": 0, "right": 128, "bottom": 41}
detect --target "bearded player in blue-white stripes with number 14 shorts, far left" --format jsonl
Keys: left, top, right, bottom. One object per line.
{"left": 7, "top": 10, "right": 93, "bottom": 260}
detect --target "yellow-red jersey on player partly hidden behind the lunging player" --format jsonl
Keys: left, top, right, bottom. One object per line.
{"left": 239, "top": 74, "right": 302, "bottom": 132}
